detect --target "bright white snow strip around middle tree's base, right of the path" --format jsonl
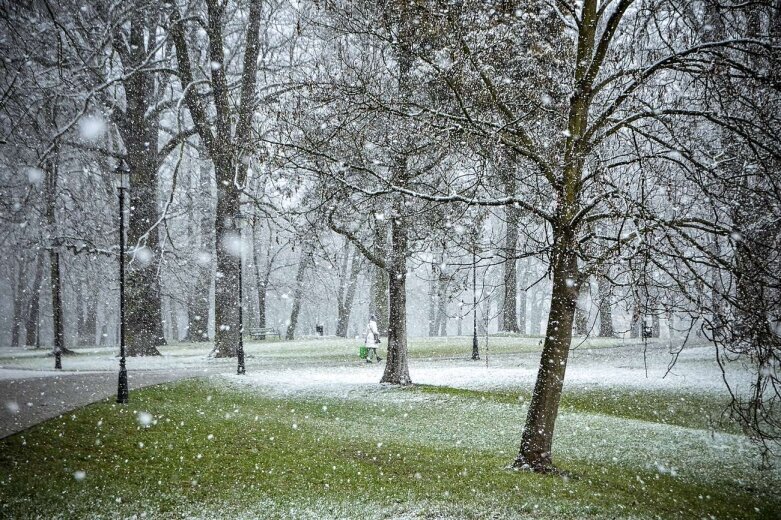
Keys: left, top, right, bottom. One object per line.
{"left": 219, "top": 346, "right": 745, "bottom": 398}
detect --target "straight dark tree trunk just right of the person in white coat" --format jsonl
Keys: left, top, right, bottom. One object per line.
{"left": 380, "top": 199, "right": 412, "bottom": 385}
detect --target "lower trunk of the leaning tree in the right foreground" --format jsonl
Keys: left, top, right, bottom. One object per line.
{"left": 513, "top": 229, "right": 578, "bottom": 471}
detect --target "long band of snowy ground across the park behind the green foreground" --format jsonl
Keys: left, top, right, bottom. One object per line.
{"left": 0, "top": 339, "right": 746, "bottom": 397}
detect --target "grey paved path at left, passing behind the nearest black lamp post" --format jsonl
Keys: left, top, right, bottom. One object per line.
{"left": 0, "top": 369, "right": 213, "bottom": 438}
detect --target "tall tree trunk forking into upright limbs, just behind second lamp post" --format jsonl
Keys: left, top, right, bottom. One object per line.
{"left": 169, "top": 0, "right": 263, "bottom": 357}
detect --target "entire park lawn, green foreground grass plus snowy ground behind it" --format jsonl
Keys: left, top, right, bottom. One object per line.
{"left": 0, "top": 338, "right": 781, "bottom": 518}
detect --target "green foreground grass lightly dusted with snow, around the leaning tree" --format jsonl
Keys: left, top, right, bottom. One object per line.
{"left": 0, "top": 381, "right": 781, "bottom": 518}
